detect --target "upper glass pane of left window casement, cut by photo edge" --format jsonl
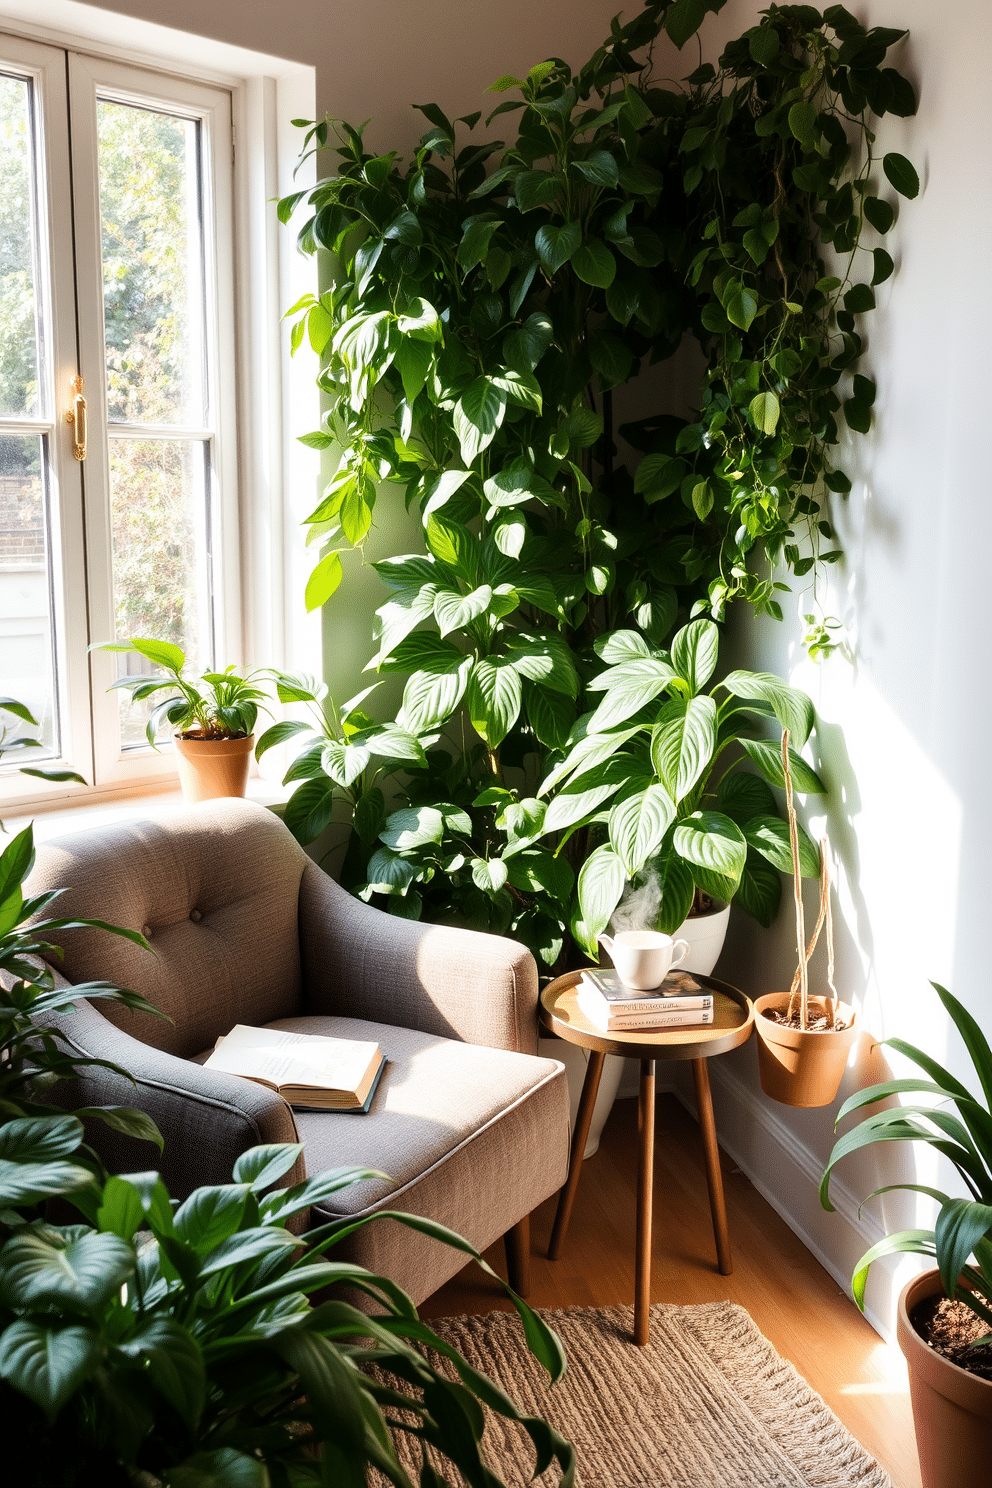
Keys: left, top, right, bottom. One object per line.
{"left": 0, "top": 74, "right": 39, "bottom": 417}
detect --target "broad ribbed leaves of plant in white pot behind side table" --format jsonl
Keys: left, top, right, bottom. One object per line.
{"left": 541, "top": 620, "right": 825, "bottom": 957}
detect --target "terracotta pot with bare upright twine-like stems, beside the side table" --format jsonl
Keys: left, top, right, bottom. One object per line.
{"left": 754, "top": 729, "right": 861, "bottom": 1107}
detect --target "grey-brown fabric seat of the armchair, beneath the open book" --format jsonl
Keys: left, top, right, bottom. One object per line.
{"left": 198, "top": 1016, "right": 568, "bottom": 1302}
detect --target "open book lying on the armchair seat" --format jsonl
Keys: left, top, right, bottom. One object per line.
{"left": 204, "top": 1024, "right": 385, "bottom": 1112}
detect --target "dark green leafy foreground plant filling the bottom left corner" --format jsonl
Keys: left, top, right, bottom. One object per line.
{"left": 0, "top": 827, "right": 574, "bottom": 1488}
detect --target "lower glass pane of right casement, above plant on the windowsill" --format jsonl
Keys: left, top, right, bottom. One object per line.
{"left": 110, "top": 439, "right": 213, "bottom": 748}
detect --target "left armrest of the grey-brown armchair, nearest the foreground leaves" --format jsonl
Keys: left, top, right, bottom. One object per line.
{"left": 36, "top": 973, "right": 305, "bottom": 1198}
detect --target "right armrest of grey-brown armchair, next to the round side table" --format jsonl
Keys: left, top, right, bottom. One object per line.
{"left": 299, "top": 863, "right": 537, "bottom": 1054}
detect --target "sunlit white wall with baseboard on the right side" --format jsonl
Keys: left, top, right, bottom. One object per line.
{"left": 675, "top": 0, "right": 992, "bottom": 1345}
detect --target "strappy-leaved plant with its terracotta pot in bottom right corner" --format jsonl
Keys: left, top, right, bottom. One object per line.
{"left": 819, "top": 982, "right": 992, "bottom": 1488}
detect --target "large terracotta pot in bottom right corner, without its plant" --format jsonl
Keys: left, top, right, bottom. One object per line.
{"left": 895, "top": 1271, "right": 992, "bottom": 1488}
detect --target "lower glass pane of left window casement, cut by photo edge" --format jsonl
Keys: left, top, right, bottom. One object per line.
{"left": 0, "top": 434, "right": 59, "bottom": 765}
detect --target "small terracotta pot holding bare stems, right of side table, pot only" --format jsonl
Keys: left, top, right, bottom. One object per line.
{"left": 754, "top": 992, "right": 861, "bottom": 1107}
